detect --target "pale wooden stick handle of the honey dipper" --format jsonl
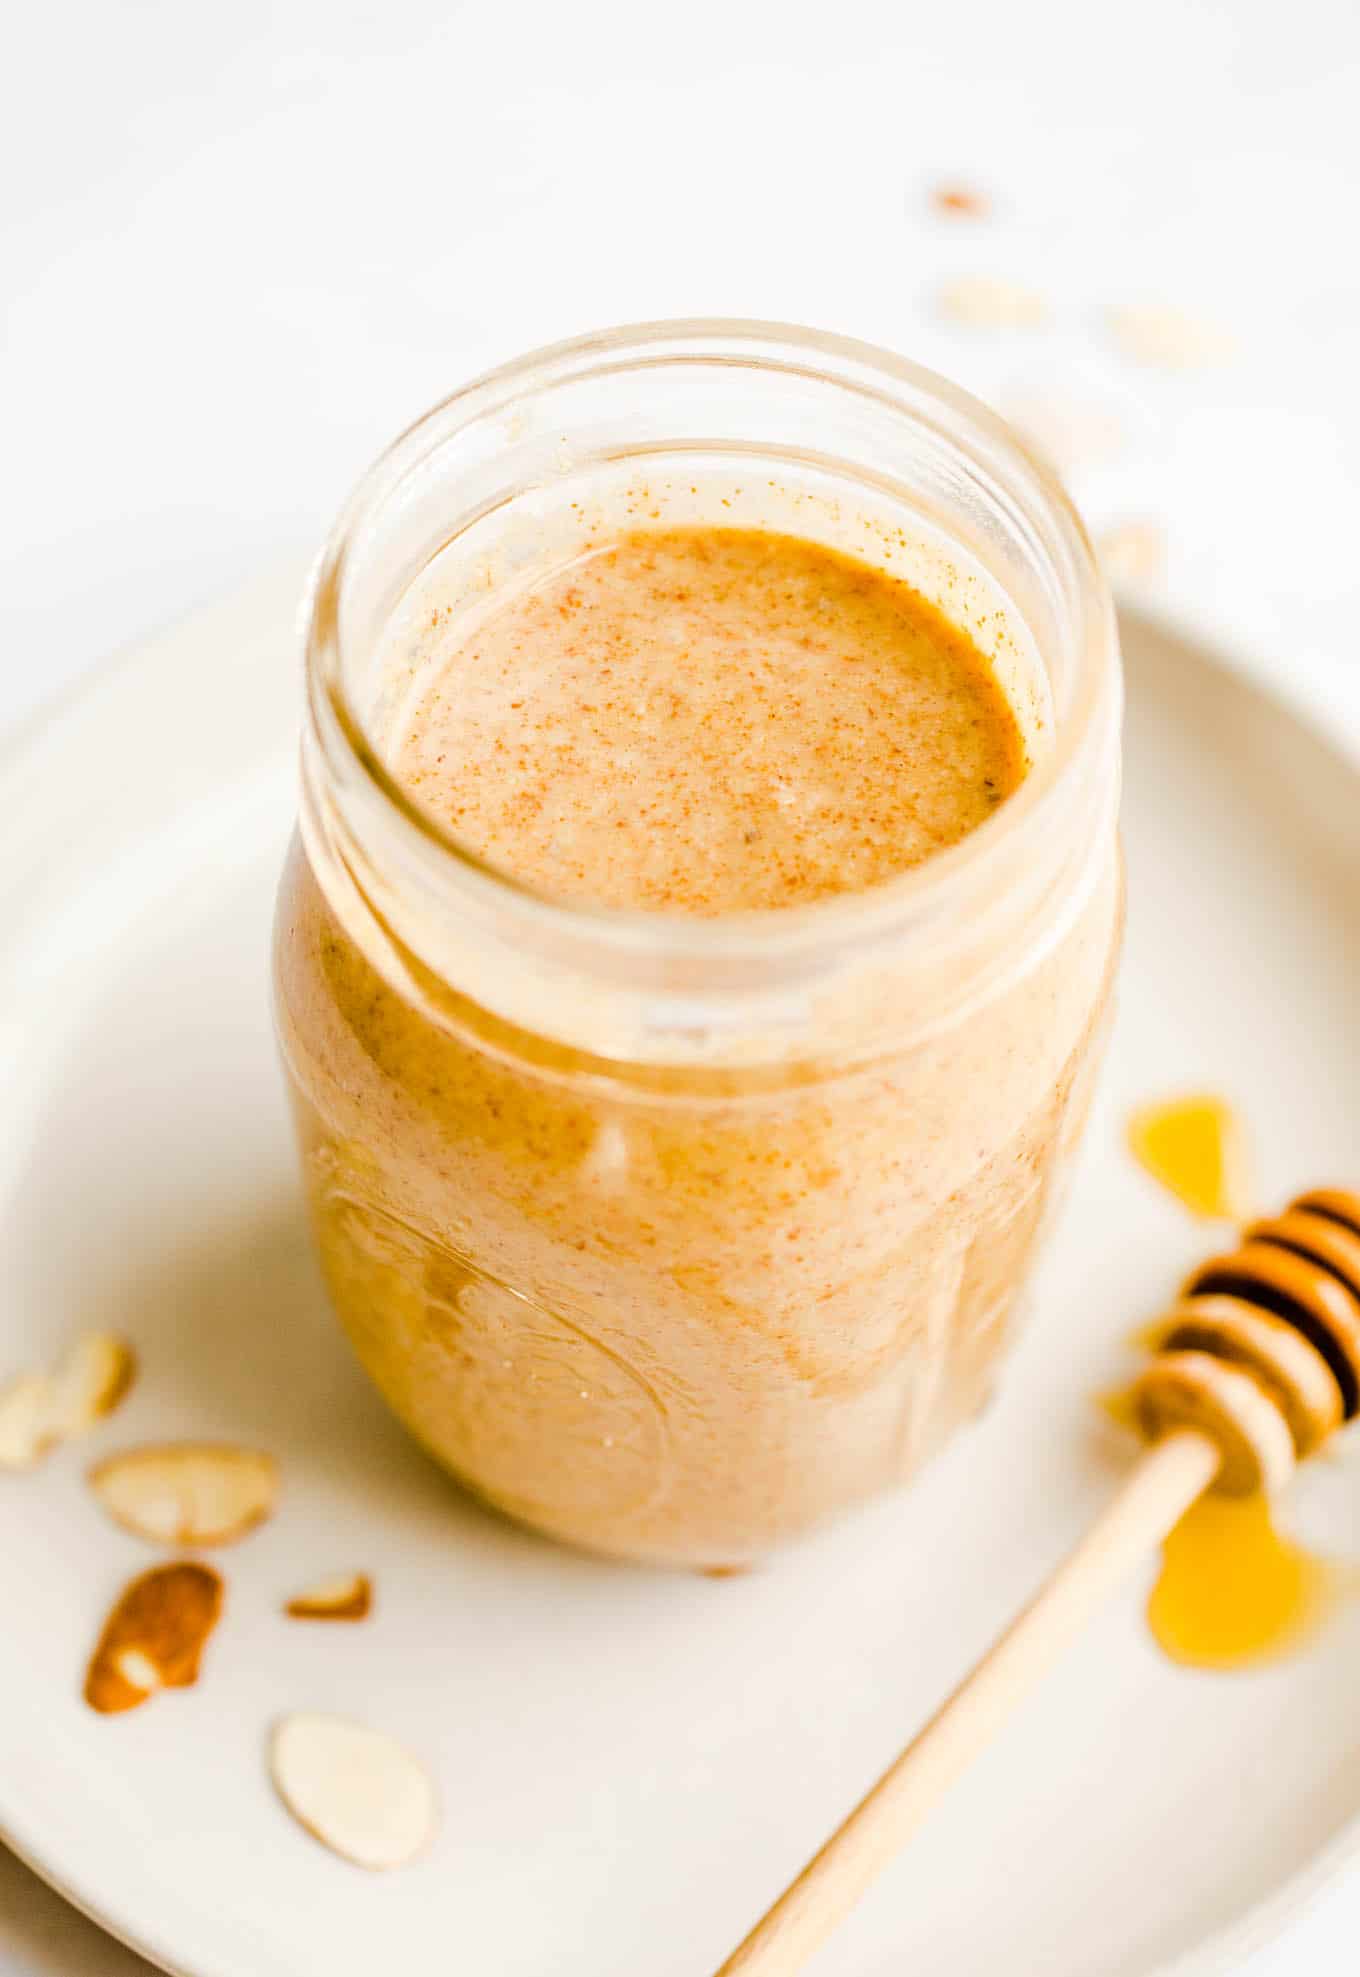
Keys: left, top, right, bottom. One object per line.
{"left": 718, "top": 1429, "right": 1220, "bottom": 1977}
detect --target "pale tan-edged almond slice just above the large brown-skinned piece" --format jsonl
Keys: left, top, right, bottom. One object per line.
{"left": 89, "top": 1441, "right": 279, "bottom": 1544}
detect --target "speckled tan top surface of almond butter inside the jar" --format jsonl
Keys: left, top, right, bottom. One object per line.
{"left": 393, "top": 528, "right": 1026, "bottom": 915}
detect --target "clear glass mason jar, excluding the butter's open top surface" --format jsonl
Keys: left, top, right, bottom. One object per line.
{"left": 275, "top": 322, "right": 1121, "bottom": 1566}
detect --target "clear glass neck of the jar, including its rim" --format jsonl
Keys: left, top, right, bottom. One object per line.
{"left": 302, "top": 320, "right": 1121, "bottom": 1068}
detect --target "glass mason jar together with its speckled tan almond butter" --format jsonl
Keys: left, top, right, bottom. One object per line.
{"left": 275, "top": 326, "right": 1123, "bottom": 1570}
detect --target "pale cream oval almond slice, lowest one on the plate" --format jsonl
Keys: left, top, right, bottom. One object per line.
{"left": 269, "top": 1714, "right": 435, "bottom": 1868}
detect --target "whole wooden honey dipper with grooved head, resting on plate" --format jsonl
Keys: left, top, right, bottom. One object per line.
{"left": 718, "top": 1188, "right": 1360, "bottom": 1977}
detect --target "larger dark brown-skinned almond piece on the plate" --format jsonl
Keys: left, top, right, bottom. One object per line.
{"left": 85, "top": 1560, "right": 221, "bottom": 1716}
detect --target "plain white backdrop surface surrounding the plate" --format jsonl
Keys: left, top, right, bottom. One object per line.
{"left": 0, "top": 0, "right": 1360, "bottom": 1977}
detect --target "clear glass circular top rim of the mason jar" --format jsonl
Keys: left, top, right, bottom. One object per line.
{"left": 304, "top": 316, "right": 1121, "bottom": 971}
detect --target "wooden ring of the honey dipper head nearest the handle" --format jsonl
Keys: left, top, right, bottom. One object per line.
{"left": 1133, "top": 1352, "right": 1295, "bottom": 1497}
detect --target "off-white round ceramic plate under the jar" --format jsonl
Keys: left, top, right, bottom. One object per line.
{"left": 0, "top": 573, "right": 1360, "bottom": 1977}
